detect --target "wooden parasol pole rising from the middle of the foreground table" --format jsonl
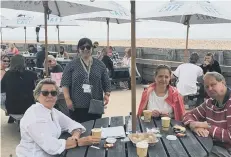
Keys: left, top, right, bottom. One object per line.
{"left": 130, "top": 0, "right": 137, "bottom": 133}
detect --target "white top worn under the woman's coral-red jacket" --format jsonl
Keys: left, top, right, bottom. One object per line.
{"left": 147, "top": 91, "right": 173, "bottom": 115}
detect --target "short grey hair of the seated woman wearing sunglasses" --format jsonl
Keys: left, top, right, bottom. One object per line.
{"left": 34, "top": 78, "right": 60, "bottom": 100}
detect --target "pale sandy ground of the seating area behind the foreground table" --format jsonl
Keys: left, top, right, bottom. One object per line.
{"left": 1, "top": 85, "right": 143, "bottom": 157}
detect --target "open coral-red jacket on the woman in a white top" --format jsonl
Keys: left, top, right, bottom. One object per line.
{"left": 138, "top": 83, "right": 185, "bottom": 120}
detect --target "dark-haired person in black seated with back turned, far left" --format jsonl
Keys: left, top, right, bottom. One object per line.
{"left": 1, "top": 55, "right": 37, "bottom": 123}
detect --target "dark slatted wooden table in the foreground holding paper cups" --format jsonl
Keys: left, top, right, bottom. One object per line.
{"left": 60, "top": 116, "right": 213, "bottom": 157}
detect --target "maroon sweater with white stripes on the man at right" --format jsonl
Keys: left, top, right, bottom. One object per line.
{"left": 183, "top": 89, "right": 231, "bottom": 150}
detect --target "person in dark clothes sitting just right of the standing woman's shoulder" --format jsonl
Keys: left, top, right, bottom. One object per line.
{"left": 101, "top": 48, "right": 114, "bottom": 77}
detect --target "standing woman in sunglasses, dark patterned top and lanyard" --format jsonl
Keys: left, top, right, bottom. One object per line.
{"left": 61, "top": 38, "right": 111, "bottom": 122}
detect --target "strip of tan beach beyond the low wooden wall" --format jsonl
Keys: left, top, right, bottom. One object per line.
{"left": 3, "top": 38, "right": 231, "bottom": 50}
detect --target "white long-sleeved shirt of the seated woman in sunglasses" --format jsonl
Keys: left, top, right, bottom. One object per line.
{"left": 16, "top": 103, "right": 86, "bottom": 157}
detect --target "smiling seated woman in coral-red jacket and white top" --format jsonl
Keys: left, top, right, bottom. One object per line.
{"left": 138, "top": 65, "right": 185, "bottom": 120}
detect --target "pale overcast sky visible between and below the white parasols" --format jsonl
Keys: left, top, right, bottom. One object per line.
{"left": 1, "top": 0, "right": 231, "bottom": 41}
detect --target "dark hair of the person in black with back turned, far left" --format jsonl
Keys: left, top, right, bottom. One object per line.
{"left": 10, "top": 55, "right": 25, "bottom": 72}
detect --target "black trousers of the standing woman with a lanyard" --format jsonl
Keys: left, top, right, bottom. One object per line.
{"left": 70, "top": 108, "right": 102, "bottom": 123}
